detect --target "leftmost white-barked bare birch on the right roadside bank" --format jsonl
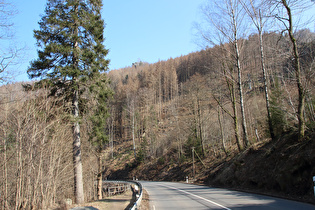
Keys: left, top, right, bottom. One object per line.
{"left": 198, "top": 0, "right": 249, "bottom": 148}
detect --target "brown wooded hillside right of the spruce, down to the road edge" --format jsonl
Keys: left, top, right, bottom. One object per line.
{"left": 104, "top": 33, "right": 315, "bottom": 205}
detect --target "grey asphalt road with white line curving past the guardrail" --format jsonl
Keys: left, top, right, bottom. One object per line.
{"left": 141, "top": 181, "right": 315, "bottom": 210}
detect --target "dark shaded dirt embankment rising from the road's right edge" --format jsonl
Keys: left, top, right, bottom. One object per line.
{"left": 204, "top": 133, "right": 315, "bottom": 203}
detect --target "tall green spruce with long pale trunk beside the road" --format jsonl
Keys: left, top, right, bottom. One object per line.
{"left": 27, "top": 0, "right": 109, "bottom": 203}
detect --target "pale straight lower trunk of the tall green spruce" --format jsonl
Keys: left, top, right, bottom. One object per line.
{"left": 72, "top": 90, "right": 84, "bottom": 204}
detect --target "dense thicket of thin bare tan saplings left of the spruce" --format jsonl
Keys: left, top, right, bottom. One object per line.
{"left": 0, "top": 88, "right": 73, "bottom": 209}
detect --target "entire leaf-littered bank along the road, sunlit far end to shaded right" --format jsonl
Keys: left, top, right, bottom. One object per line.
{"left": 106, "top": 132, "right": 315, "bottom": 203}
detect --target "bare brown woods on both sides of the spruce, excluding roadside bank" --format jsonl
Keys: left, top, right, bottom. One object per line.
{"left": 1, "top": 27, "right": 315, "bottom": 208}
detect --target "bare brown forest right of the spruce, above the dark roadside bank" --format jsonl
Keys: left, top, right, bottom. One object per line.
{"left": 108, "top": 27, "right": 314, "bottom": 158}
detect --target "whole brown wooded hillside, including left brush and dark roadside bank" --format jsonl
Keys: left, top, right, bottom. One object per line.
{"left": 0, "top": 30, "right": 315, "bottom": 209}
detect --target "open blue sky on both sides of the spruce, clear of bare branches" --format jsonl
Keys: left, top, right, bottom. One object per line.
{"left": 8, "top": 0, "right": 204, "bottom": 81}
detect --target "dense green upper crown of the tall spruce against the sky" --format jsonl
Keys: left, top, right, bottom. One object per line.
{"left": 27, "top": 0, "right": 109, "bottom": 85}
